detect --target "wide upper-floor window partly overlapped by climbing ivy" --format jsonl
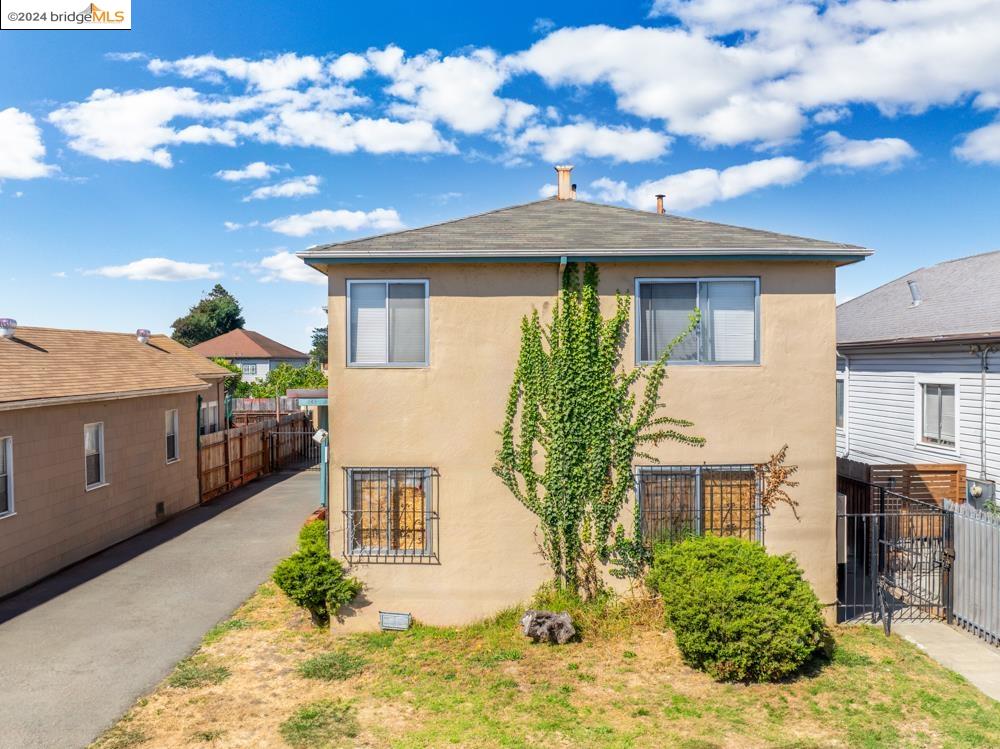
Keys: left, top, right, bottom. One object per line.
{"left": 636, "top": 278, "right": 760, "bottom": 364}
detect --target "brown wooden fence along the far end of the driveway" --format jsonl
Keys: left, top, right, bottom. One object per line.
{"left": 198, "top": 411, "right": 310, "bottom": 502}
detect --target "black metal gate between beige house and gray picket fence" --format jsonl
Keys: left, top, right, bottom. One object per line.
{"left": 837, "top": 476, "right": 955, "bottom": 632}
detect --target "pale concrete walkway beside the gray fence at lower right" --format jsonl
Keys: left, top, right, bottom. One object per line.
{"left": 892, "top": 622, "right": 1000, "bottom": 700}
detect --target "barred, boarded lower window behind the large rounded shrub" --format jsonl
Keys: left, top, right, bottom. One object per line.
{"left": 636, "top": 465, "right": 764, "bottom": 544}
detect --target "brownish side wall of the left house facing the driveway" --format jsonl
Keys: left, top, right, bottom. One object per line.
{"left": 0, "top": 391, "right": 201, "bottom": 595}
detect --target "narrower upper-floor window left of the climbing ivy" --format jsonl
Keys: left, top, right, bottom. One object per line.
{"left": 347, "top": 281, "right": 428, "bottom": 367}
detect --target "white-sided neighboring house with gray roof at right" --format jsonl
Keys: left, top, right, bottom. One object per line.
{"left": 836, "top": 252, "right": 1000, "bottom": 499}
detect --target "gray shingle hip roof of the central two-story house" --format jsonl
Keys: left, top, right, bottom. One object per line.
{"left": 299, "top": 198, "right": 871, "bottom": 264}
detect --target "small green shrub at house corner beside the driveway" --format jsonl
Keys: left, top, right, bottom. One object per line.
{"left": 271, "top": 520, "right": 361, "bottom": 626}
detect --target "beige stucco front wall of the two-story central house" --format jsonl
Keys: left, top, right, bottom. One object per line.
{"left": 329, "top": 261, "right": 836, "bottom": 627}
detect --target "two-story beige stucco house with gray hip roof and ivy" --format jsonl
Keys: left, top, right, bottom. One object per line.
{"left": 300, "top": 168, "right": 870, "bottom": 626}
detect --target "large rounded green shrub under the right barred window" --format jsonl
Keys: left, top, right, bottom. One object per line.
{"left": 648, "top": 536, "right": 829, "bottom": 681}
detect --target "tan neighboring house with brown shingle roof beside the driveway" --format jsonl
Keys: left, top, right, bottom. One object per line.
{"left": 0, "top": 321, "right": 229, "bottom": 595}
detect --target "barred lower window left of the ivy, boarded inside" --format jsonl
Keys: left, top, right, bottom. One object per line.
{"left": 344, "top": 468, "right": 438, "bottom": 563}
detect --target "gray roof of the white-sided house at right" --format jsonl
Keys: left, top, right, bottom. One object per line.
{"left": 837, "top": 251, "right": 1000, "bottom": 345}
